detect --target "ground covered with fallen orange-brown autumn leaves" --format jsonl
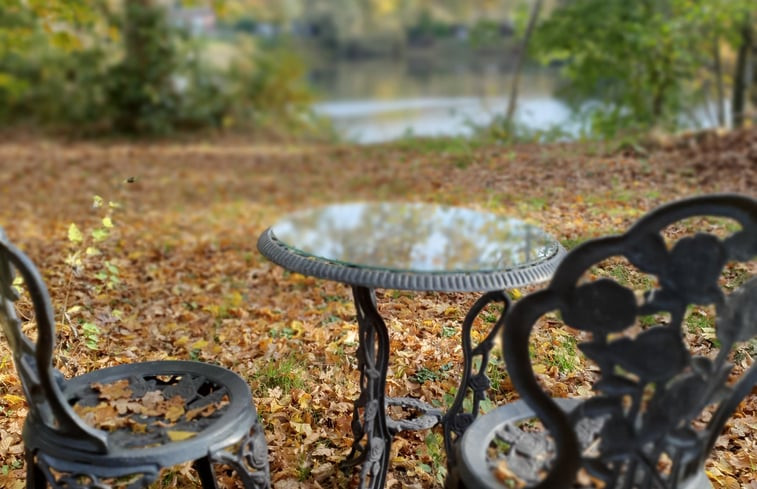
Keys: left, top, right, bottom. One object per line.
{"left": 0, "top": 131, "right": 757, "bottom": 488}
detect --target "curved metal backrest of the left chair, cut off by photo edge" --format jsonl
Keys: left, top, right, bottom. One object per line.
{"left": 0, "top": 228, "right": 107, "bottom": 452}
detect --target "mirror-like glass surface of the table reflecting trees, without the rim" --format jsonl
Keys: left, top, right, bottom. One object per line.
{"left": 273, "top": 203, "right": 556, "bottom": 272}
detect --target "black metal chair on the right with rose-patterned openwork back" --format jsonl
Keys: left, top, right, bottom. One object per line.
{"left": 448, "top": 195, "right": 757, "bottom": 489}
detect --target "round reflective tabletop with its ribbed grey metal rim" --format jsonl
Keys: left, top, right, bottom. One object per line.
{"left": 259, "top": 202, "right": 564, "bottom": 290}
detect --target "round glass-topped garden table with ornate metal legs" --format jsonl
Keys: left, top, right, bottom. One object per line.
{"left": 258, "top": 202, "right": 565, "bottom": 488}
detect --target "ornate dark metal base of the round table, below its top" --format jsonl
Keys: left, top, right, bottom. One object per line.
{"left": 341, "top": 286, "right": 510, "bottom": 489}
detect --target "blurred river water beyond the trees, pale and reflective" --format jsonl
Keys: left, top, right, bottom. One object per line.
{"left": 309, "top": 59, "right": 578, "bottom": 143}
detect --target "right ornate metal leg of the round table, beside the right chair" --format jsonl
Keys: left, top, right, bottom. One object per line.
{"left": 441, "top": 290, "right": 510, "bottom": 470}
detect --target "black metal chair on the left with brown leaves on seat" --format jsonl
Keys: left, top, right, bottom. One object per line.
{"left": 0, "top": 229, "right": 270, "bottom": 489}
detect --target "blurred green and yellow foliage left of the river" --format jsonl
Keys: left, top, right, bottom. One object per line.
{"left": 0, "top": 0, "right": 317, "bottom": 135}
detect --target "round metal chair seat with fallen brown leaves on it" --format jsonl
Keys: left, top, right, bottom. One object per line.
{"left": 25, "top": 361, "right": 265, "bottom": 472}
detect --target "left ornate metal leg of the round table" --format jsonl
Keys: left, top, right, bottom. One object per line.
{"left": 342, "top": 286, "right": 392, "bottom": 489}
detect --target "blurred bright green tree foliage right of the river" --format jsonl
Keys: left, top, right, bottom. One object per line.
{"left": 532, "top": 0, "right": 748, "bottom": 136}
